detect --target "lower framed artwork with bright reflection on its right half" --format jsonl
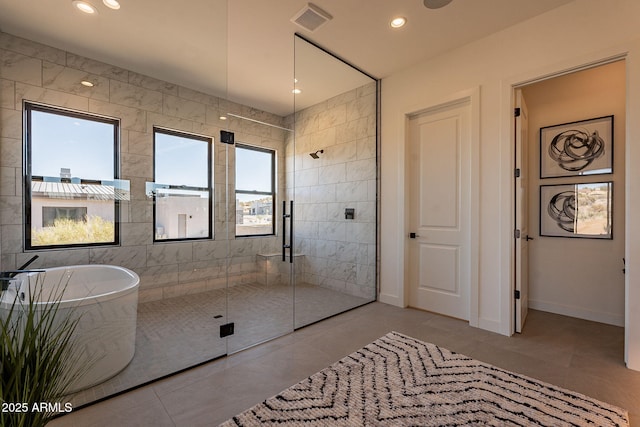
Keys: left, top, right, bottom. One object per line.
{"left": 540, "top": 181, "right": 613, "bottom": 239}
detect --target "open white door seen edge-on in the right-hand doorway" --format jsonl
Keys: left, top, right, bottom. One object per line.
{"left": 514, "top": 89, "right": 533, "bottom": 332}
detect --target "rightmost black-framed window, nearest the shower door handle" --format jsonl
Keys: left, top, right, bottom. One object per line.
{"left": 236, "top": 144, "right": 276, "bottom": 236}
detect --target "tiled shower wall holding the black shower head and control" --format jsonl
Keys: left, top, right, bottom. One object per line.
{"left": 286, "top": 82, "right": 377, "bottom": 298}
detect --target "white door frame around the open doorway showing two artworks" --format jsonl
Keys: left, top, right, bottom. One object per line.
{"left": 500, "top": 52, "right": 638, "bottom": 334}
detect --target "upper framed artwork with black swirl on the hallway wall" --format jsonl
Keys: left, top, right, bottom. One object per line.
{"left": 540, "top": 116, "right": 613, "bottom": 178}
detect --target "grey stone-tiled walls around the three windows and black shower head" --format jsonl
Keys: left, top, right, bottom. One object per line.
{"left": 0, "top": 32, "right": 376, "bottom": 301}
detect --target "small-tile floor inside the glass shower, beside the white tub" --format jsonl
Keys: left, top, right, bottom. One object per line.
{"left": 69, "top": 283, "right": 368, "bottom": 407}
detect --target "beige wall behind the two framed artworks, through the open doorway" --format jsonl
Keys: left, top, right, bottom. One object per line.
{"left": 523, "top": 61, "right": 626, "bottom": 326}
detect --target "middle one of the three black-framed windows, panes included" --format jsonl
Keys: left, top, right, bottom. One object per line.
{"left": 152, "top": 128, "right": 213, "bottom": 241}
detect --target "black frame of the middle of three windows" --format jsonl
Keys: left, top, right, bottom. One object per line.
{"left": 152, "top": 126, "right": 214, "bottom": 244}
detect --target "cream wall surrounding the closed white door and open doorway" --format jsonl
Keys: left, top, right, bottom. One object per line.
{"left": 379, "top": 0, "right": 640, "bottom": 369}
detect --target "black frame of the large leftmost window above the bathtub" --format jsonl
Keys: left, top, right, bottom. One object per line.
{"left": 22, "top": 100, "right": 120, "bottom": 251}
